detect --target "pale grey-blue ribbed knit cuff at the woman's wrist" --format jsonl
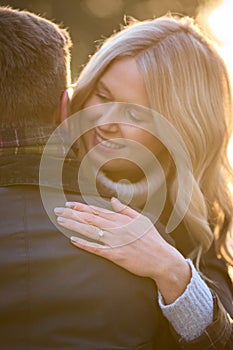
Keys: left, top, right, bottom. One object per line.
{"left": 158, "top": 259, "right": 214, "bottom": 341}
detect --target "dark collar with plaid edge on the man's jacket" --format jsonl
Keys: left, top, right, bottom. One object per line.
{"left": 0, "top": 126, "right": 79, "bottom": 192}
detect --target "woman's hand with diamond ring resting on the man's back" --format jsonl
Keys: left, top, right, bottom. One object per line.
{"left": 55, "top": 198, "right": 191, "bottom": 304}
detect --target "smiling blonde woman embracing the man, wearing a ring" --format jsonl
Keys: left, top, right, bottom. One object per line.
{"left": 55, "top": 16, "right": 233, "bottom": 349}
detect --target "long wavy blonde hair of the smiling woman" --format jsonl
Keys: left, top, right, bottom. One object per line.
{"left": 72, "top": 15, "right": 233, "bottom": 257}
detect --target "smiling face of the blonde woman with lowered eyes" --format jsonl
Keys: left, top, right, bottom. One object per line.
{"left": 79, "top": 57, "right": 164, "bottom": 181}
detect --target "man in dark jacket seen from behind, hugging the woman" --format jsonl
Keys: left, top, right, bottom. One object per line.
{"left": 0, "top": 7, "right": 160, "bottom": 350}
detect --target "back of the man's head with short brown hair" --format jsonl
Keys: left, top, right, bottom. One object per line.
{"left": 0, "top": 7, "right": 71, "bottom": 128}
